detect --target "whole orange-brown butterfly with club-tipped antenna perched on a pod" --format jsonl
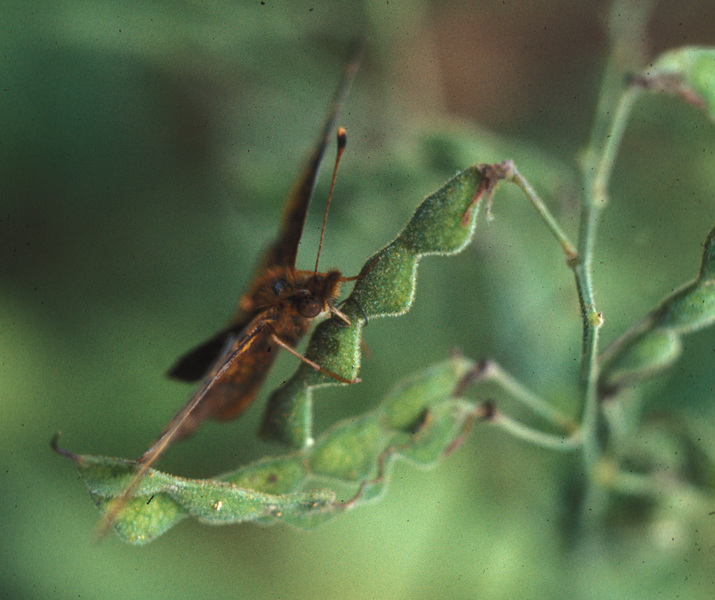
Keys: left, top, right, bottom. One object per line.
{"left": 100, "top": 49, "right": 361, "bottom": 533}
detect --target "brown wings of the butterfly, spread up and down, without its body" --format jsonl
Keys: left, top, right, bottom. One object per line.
{"left": 98, "top": 44, "right": 362, "bottom": 535}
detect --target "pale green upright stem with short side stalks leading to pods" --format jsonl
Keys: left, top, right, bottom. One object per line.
{"left": 504, "top": 0, "right": 652, "bottom": 502}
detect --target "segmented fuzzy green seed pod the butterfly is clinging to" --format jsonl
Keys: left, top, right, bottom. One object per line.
{"left": 261, "top": 166, "right": 484, "bottom": 448}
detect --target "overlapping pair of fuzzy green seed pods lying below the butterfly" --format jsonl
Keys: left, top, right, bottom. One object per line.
{"left": 54, "top": 357, "right": 475, "bottom": 544}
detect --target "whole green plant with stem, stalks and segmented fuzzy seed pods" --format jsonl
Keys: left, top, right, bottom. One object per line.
{"left": 54, "top": 2, "right": 715, "bottom": 544}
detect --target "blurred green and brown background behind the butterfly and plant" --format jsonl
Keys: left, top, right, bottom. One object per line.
{"left": 0, "top": 0, "right": 715, "bottom": 599}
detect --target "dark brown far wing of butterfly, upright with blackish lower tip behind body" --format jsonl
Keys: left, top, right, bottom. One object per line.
{"left": 167, "top": 43, "right": 362, "bottom": 381}
